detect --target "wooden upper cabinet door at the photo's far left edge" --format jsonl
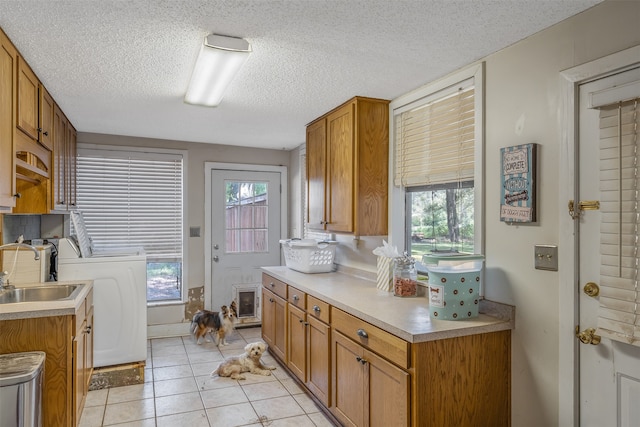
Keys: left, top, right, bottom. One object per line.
{"left": 0, "top": 31, "right": 18, "bottom": 208}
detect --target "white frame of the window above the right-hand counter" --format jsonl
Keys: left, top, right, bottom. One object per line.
{"left": 388, "top": 62, "right": 485, "bottom": 254}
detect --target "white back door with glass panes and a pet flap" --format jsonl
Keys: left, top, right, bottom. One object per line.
{"left": 205, "top": 169, "right": 285, "bottom": 311}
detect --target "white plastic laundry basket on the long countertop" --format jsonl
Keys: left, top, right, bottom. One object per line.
{"left": 280, "top": 239, "right": 338, "bottom": 273}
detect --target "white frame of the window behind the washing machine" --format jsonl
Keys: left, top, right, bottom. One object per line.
{"left": 78, "top": 142, "right": 189, "bottom": 307}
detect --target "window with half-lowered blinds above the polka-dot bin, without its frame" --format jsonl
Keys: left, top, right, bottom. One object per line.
{"left": 394, "top": 78, "right": 477, "bottom": 258}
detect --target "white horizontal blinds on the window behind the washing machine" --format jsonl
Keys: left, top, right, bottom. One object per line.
{"left": 78, "top": 149, "right": 183, "bottom": 261}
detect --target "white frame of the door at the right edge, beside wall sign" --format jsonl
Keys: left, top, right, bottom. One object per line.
{"left": 558, "top": 45, "right": 640, "bottom": 427}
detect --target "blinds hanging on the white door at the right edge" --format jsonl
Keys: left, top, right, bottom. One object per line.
{"left": 598, "top": 100, "right": 640, "bottom": 346}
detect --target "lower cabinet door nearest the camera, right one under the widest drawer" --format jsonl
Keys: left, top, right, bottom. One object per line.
{"left": 363, "top": 350, "right": 410, "bottom": 427}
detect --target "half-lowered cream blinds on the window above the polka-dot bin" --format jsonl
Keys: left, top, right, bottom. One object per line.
{"left": 394, "top": 86, "right": 475, "bottom": 187}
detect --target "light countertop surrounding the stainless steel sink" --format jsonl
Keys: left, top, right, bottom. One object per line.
{"left": 0, "top": 280, "right": 93, "bottom": 320}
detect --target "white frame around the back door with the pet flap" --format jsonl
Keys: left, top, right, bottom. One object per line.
{"left": 202, "top": 162, "right": 289, "bottom": 310}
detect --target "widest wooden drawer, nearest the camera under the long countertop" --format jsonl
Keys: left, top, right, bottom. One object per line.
{"left": 331, "top": 307, "right": 409, "bottom": 369}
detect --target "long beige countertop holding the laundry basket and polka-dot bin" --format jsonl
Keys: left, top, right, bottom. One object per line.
{"left": 262, "top": 266, "right": 515, "bottom": 343}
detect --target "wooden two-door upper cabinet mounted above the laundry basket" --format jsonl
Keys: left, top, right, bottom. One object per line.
{"left": 307, "top": 97, "right": 389, "bottom": 236}
